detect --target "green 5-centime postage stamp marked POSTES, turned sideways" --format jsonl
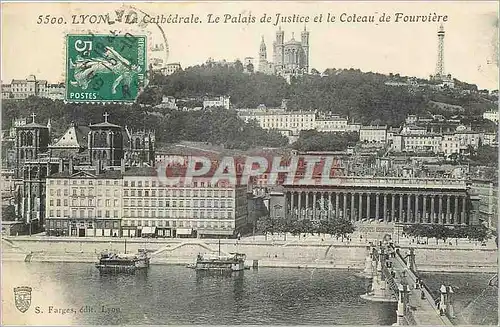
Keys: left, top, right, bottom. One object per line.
{"left": 65, "top": 33, "right": 147, "bottom": 102}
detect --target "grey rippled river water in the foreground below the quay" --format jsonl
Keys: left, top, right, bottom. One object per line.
{"left": 2, "top": 262, "right": 496, "bottom": 325}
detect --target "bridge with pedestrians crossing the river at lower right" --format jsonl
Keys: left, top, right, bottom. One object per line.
{"left": 361, "top": 240, "right": 456, "bottom": 326}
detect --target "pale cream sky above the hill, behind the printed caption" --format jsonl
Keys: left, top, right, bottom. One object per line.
{"left": 1, "top": 1, "right": 499, "bottom": 90}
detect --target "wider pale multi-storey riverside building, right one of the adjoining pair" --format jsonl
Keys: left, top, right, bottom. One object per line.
{"left": 122, "top": 168, "right": 248, "bottom": 237}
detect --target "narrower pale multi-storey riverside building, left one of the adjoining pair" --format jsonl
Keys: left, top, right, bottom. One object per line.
{"left": 45, "top": 171, "right": 123, "bottom": 237}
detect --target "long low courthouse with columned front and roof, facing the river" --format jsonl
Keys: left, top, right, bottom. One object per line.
{"left": 283, "top": 177, "right": 480, "bottom": 225}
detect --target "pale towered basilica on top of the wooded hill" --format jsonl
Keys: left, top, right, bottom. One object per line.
{"left": 258, "top": 27, "right": 309, "bottom": 80}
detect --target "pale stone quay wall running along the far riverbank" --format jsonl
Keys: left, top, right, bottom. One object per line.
{"left": 1, "top": 236, "right": 498, "bottom": 272}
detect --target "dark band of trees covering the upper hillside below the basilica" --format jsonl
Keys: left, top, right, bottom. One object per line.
{"left": 146, "top": 64, "right": 497, "bottom": 126}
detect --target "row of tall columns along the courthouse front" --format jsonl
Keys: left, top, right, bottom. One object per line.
{"left": 285, "top": 190, "right": 469, "bottom": 225}
